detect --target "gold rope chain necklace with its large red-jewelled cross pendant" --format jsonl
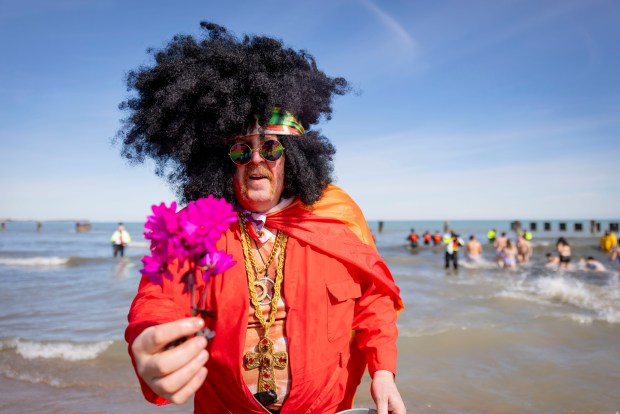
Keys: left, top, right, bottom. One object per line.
{"left": 239, "top": 215, "right": 288, "bottom": 406}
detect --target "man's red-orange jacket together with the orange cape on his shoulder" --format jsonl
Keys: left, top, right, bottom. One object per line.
{"left": 125, "top": 186, "right": 403, "bottom": 414}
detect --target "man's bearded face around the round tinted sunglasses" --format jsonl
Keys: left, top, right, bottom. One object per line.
{"left": 234, "top": 135, "right": 285, "bottom": 213}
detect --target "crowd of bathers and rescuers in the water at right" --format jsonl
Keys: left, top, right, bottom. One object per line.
{"left": 407, "top": 229, "right": 620, "bottom": 272}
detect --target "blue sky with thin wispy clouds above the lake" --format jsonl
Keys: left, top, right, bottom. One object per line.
{"left": 0, "top": 0, "right": 620, "bottom": 221}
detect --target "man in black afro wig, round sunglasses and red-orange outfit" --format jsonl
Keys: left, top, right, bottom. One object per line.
{"left": 119, "top": 23, "right": 405, "bottom": 414}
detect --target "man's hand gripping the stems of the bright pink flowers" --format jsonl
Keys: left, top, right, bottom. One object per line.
{"left": 131, "top": 318, "right": 209, "bottom": 404}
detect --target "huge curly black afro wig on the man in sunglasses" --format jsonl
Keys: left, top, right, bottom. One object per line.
{"left": 117, "top": 22, "right": 350, "bottom": 204}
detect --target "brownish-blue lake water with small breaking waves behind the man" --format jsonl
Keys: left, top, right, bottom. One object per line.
{"left": 0, "top": 220, "right": 620, "bottom": 414}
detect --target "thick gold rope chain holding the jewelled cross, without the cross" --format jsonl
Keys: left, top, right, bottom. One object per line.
{"left": 239, "top": 214, "right": 288, "bottom": 330}
